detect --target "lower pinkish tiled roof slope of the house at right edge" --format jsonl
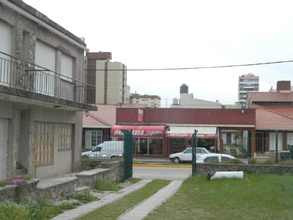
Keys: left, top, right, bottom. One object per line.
{"left": 252, "top": 105, "right": 293, "bottom": 131}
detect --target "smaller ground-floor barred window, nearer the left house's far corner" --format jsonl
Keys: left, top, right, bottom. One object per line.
{"left": 58, "top": 124, "right": 72, "bottom": 150}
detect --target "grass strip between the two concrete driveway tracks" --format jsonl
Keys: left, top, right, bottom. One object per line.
{"left": 79, "top": 180, "right": 170, "bottom": 220}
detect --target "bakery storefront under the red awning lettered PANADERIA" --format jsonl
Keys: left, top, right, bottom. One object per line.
{"left": 111, "top": 125, "right": 166, "bottom": 156}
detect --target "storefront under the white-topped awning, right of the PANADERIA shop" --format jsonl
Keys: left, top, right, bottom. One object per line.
{"left": 166, "top": 126, "right": 217, "bottom": 153}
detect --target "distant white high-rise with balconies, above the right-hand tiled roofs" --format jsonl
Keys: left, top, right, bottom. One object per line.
{"left": 238, "top": 73, "right": 259, "bottom": 107}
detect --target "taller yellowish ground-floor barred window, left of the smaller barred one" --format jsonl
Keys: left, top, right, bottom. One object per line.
{"left": 34, "top": 122, "right": 54, "bottom": 165}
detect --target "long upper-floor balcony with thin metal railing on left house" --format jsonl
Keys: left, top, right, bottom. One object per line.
{"left": 0, "top": 52, "right": 96, "bottom": 111}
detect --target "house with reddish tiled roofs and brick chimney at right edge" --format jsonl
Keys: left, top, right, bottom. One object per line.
{"left": 247, "top": 81, "right": 293, "bottom": 153}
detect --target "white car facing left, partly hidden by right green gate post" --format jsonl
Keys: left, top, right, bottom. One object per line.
{"left": 169, "top": 147, "right": 210, "bottom": 163}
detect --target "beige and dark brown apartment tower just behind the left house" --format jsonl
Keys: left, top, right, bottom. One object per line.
{"left": 85, "top": 52, "right": 130, "bottom": 104}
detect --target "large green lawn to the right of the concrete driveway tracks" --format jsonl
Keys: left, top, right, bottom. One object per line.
{"left": 146, "top": 174, "right": 293, "bottom": 220}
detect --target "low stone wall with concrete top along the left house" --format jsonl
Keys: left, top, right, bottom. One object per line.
{"left": 0, "top": 161, "right": 124, "bottom": 203}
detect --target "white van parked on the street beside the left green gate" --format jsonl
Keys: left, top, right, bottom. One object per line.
{"left": 81, "top": 141, "right": 124, "bottom": 160}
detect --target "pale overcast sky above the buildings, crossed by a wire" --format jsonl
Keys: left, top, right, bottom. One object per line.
{"left": 24, "top": 0, "right": 293, "bottom": 107}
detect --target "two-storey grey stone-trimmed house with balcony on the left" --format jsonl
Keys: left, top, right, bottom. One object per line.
{"left": 0, "top": 0, "right": 96, "bottom": 180}
